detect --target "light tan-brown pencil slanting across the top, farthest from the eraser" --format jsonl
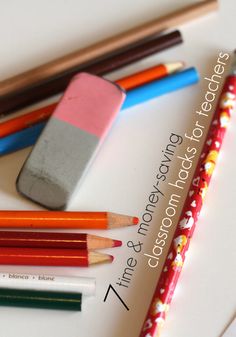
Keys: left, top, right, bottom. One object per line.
{"left": 0, "top": 0, "right": 217, "bottom": 95}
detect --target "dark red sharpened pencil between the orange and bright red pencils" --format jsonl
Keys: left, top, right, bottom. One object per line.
{"left": 0, "top": 231, "right": 122, "bottom": 250}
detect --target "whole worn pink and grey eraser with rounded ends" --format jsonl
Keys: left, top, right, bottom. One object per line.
{"left": 16, "top": 73, "right": 125, "bottom": 209}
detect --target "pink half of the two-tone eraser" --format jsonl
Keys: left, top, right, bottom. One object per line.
{"left": 53, "top": 73, "right": 125, "bottom": 138}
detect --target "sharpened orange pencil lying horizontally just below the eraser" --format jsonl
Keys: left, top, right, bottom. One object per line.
{"left": 0, "top": 211, "right": 139, "bottom": 229}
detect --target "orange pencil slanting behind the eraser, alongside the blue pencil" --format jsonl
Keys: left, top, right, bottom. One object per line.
{"left": 0, "top": 62, "right": 184, "bottom": 137}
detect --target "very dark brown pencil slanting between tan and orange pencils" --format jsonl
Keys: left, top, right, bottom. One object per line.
{"left": 0, "top": 31, "right": 183, "bottom": 114}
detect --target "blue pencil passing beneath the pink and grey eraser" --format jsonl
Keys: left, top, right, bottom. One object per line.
{"left": 0, "top": 67, "right": 199, "bottom": 155}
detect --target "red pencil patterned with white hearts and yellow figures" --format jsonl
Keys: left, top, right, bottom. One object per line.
{"left": 139, "top": 53, "right": 236, "bottom": 337}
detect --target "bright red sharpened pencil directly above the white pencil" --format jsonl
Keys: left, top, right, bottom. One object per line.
{"left": 0, "top": 247, "right": 113, "bottom": 267}
